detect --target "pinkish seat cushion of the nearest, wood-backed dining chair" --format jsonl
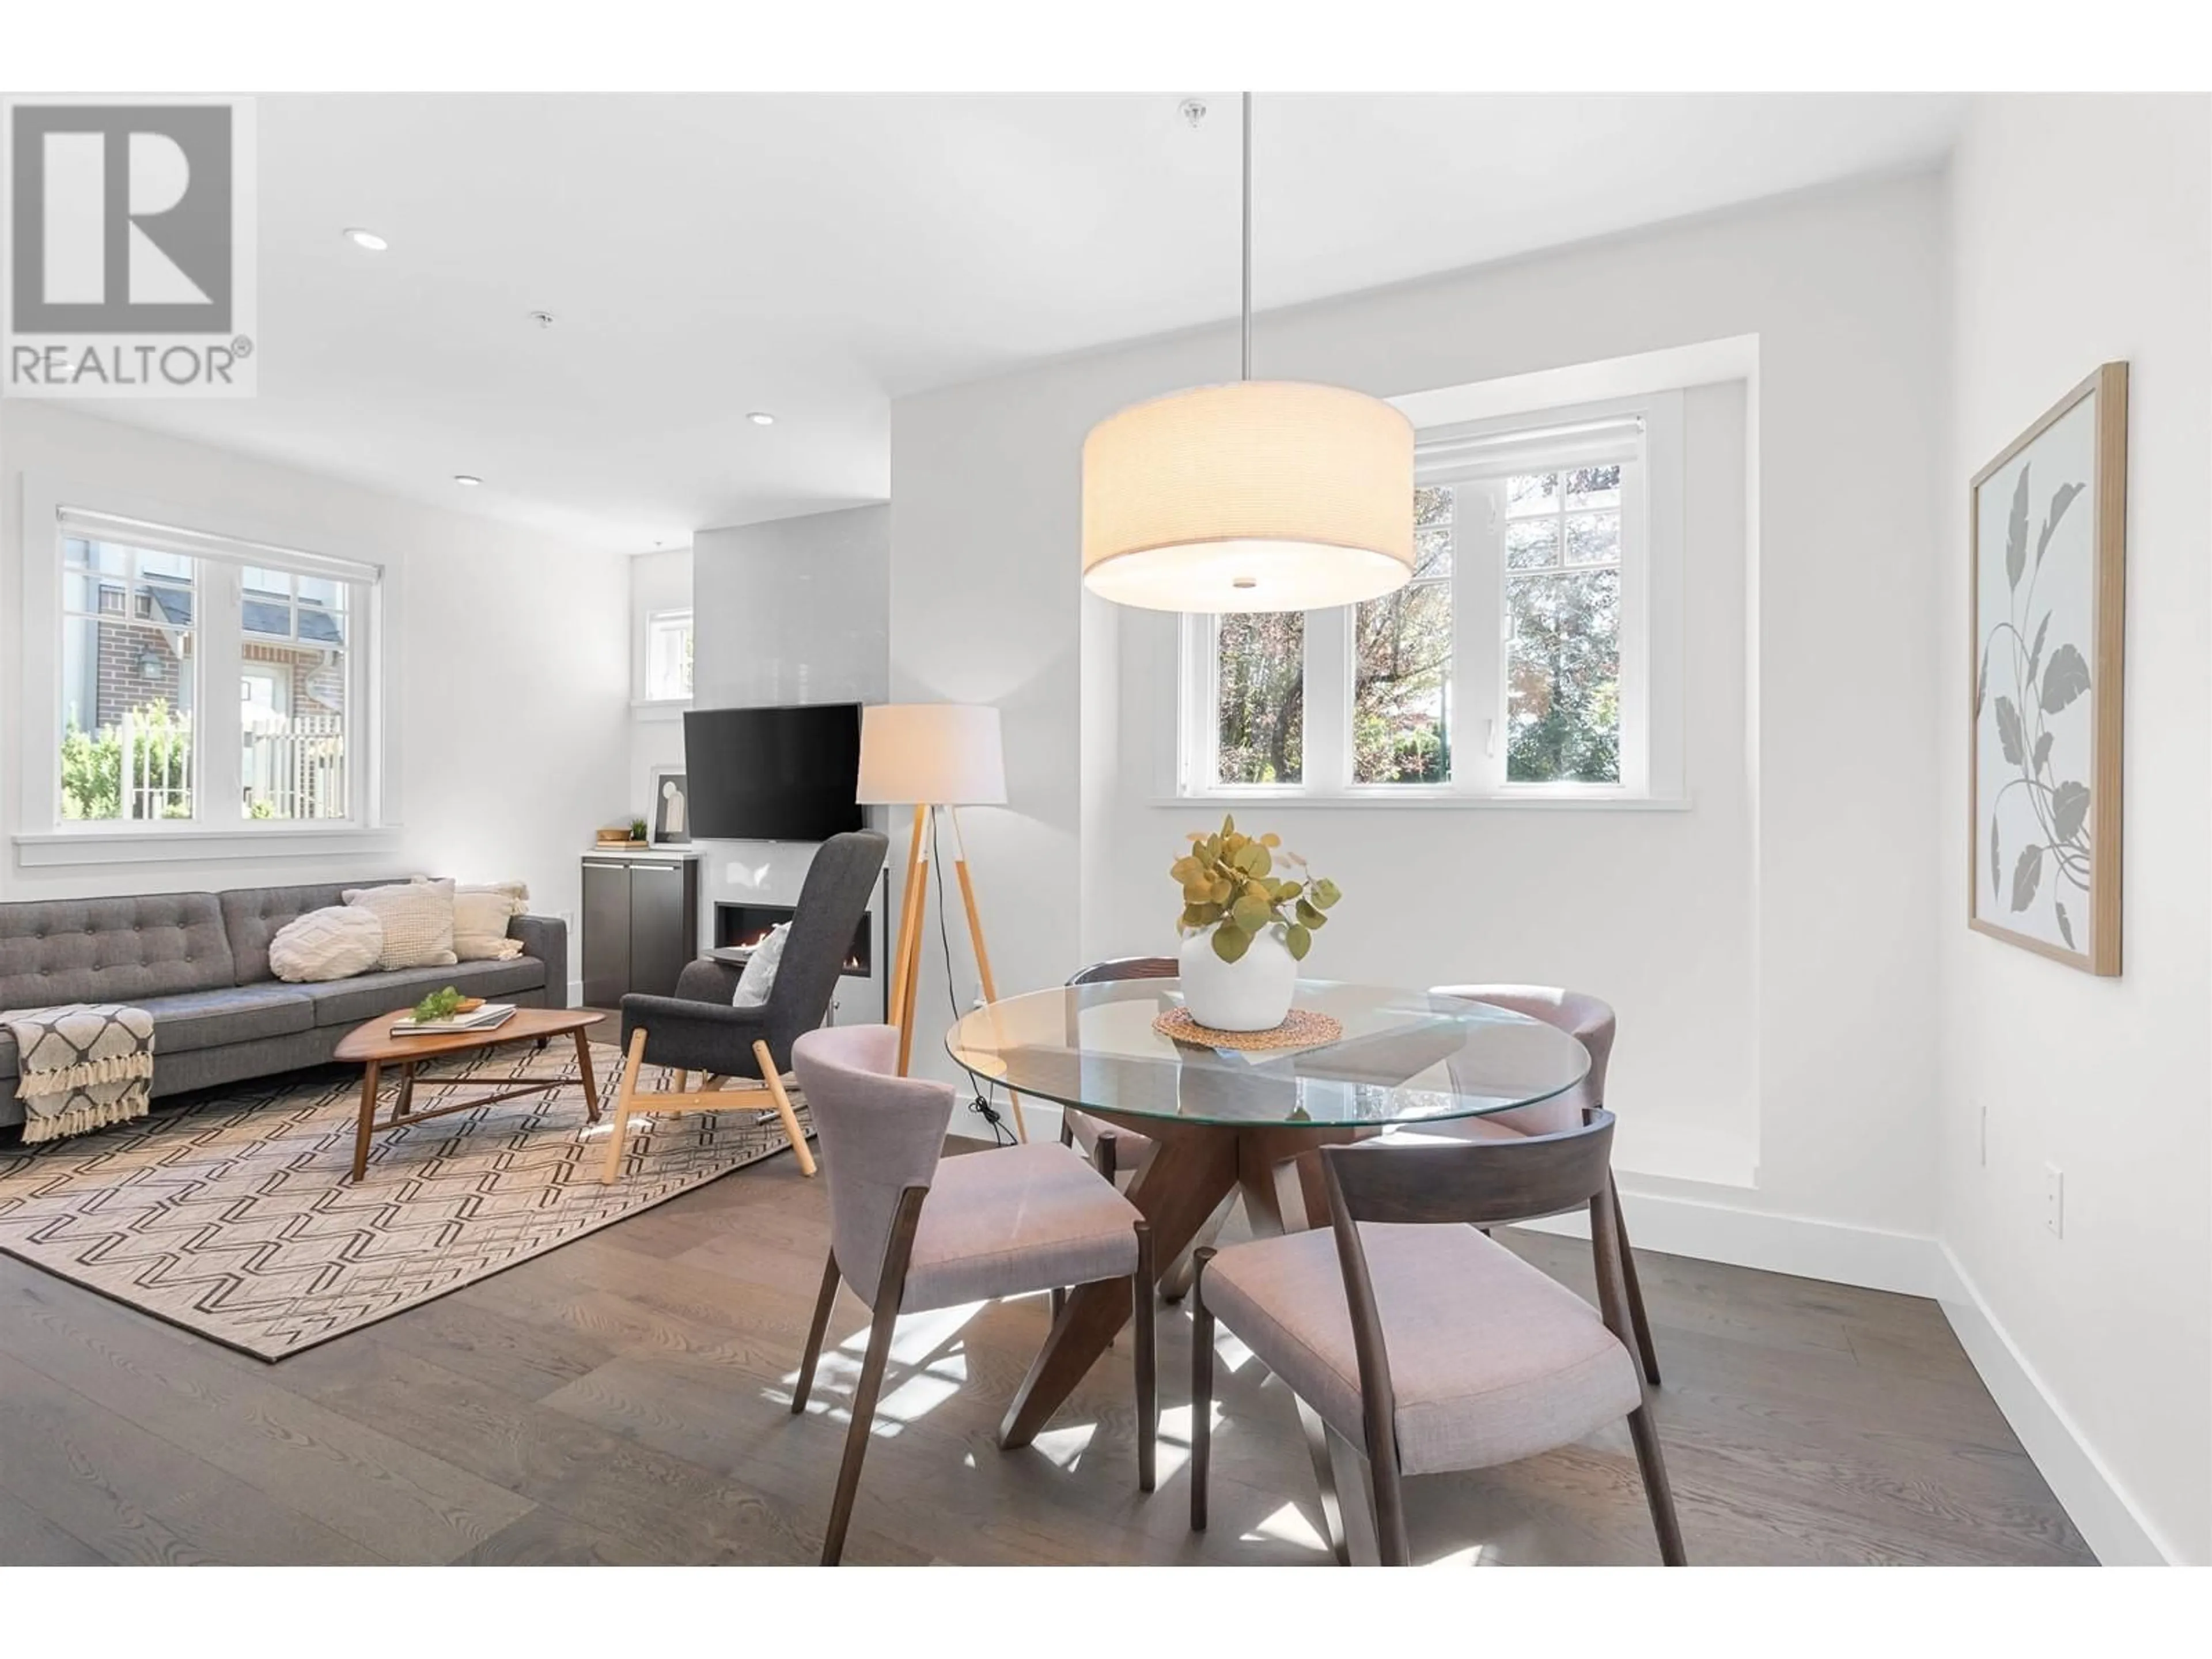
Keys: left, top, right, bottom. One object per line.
{"left": 1194, "top": 1210, "right": 1643, "bottom": 1475}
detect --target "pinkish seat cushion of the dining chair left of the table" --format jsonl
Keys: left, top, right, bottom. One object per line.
{"left": 900, "top": 1141, "right": 1137, "bottom": 1312}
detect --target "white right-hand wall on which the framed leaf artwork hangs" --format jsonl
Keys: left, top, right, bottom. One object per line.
{"left": 1929, "top": 95, "right": 2212, "bottom": 1564}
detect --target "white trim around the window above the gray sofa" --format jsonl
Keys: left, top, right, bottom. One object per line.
{"left": 9, "top": 474, "right": 403, "bottom": 867}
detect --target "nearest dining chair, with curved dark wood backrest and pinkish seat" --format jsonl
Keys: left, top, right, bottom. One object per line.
{"left": 1190, "top": 1108, "right": 1683, "bottom": 1566}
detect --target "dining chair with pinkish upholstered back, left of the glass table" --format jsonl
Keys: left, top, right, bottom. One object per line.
{"left": 792, "top": 1027, "right": 1159, "bottom": 1566}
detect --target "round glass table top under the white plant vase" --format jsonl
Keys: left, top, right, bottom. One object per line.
{"left": 945, "top": 980, "right": 1590, "bottom": 1128}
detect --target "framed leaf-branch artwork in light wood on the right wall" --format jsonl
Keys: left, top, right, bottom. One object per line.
{"left": 1967, "top": 363, "right": 2128, "bottom": 974}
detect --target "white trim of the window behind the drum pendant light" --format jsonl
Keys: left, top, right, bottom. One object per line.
{"left": 1166, "top": 385, "right": 1688, "bottom": 812}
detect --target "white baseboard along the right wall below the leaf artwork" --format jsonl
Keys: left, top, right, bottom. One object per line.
{"left": 1938, "top": 1245, "right": 2183, "bottom": 1566}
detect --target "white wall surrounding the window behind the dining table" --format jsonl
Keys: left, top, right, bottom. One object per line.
{"left": 892, "top": 177, "right": 1942, "bottom": 1243}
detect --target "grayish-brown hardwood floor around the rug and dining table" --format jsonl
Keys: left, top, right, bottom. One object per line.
{"left": 0, "top": 1157, "right": 2090, "bottom": 1564}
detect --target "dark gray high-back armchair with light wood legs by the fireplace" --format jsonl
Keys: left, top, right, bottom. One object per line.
{"left": 600, "top": 830, "right": 892, "bottom": 1181}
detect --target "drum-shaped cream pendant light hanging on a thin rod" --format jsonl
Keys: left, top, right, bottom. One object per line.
{"left": 1084, "top": 93, "right": 1414, "bottom": 611}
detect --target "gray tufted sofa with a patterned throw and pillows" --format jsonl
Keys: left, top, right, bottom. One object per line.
{"left": 0, "top": 876, "right": 569, "bottom": 1128}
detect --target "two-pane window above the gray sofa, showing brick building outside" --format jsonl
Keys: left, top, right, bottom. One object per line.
{"left": 55, "top": 509, "right": 378, "bottom": 830}
